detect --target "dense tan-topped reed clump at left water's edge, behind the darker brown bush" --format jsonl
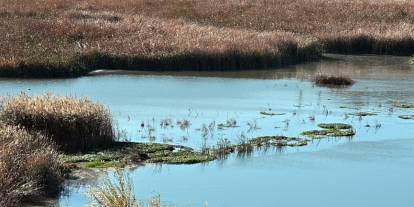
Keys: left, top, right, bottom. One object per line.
{"left": 0, "top": 94, "right": 115, "bottom": 152}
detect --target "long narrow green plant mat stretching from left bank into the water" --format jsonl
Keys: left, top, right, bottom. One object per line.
{"left": 59, "top": 136, "right": 308, "bottom": 169}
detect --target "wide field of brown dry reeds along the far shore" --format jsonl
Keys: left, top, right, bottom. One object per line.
{"left": 0, "top": 0, "right": 414, "bottom": 77}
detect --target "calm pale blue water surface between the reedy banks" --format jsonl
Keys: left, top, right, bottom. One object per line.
{"left": 0, "top": 56, "right": 414, "bottom": 207}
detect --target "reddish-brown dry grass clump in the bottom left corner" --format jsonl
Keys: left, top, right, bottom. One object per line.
{"left": 0, "top": 123, "right": 63, "bottom": 206}
